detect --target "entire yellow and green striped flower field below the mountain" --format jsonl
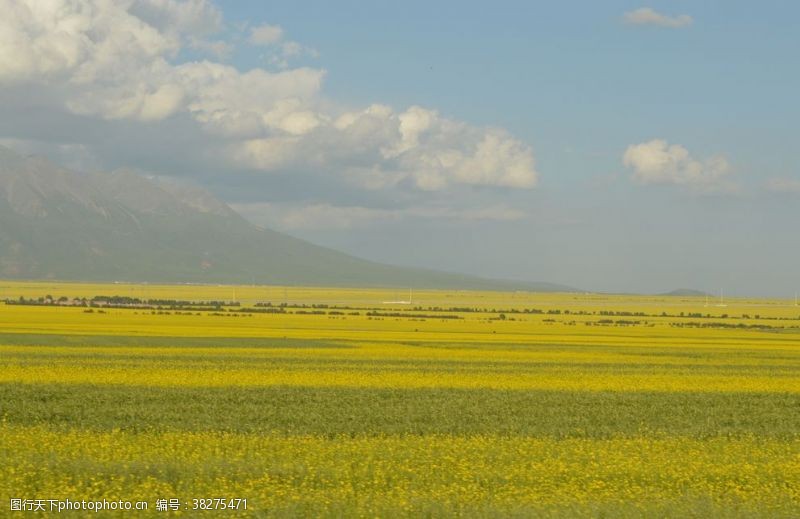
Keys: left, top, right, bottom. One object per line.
{"left": 0, "top": 282, "right": 800, "bottom": 517}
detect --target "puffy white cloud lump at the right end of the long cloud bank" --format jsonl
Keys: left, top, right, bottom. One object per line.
{"left": 232, "top": 105, "right": 538, "bottom": 191}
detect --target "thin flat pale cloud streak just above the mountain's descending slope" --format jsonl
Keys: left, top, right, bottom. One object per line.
{"left": 233, "top": 203, "right": 527, "bottom": 230}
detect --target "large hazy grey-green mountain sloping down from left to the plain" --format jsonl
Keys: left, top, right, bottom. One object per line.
{"left": 0, "top": 146, "right": 572, "bottom": 291}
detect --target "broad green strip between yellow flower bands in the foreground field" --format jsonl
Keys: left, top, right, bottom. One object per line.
{"left": 6, "top": 384, "right": 800, "bottom": 439}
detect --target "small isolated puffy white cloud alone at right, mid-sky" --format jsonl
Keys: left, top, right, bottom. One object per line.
{"left": 622, "top": 139, "right": 736, "bottom": 191}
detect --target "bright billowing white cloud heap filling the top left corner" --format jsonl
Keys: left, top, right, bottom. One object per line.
{"left": 0, "top": 0, "right": 324, "bottom": 125}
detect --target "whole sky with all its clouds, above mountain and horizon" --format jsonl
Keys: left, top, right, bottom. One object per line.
{"left": 0, "top": 0, "right": 800, "bottom": 298}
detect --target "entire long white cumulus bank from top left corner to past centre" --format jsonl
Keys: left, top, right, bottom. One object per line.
{"left": 0, "top": 0, "right": 538, "bottom": 212}
